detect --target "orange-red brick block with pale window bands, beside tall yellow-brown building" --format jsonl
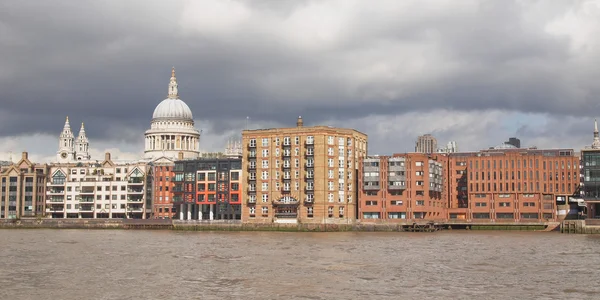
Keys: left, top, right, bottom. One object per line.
{"left": 358, "top": 153, "right": 447, "bottom": 222}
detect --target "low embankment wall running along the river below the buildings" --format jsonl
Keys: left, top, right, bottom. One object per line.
{"left": 0, "top": 219, "right": 559, "bottom": 232}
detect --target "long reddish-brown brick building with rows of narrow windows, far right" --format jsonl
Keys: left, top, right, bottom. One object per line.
{"left": 446, "top": 144, "right": 579, "bottom": 222}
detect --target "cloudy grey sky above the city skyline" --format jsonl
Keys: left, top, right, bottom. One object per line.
{"left": 0, "top": 0, "right": 600, "bottom": 162}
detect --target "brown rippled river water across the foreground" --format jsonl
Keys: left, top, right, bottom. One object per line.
{"left": 0, "top": 230, "right": 600, "bottom": 300}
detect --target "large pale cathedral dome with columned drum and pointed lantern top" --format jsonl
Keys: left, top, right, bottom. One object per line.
{"left": 144, "top": 68, "right": 200, "bottom": 160}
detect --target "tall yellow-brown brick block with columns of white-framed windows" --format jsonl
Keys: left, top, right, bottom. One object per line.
{"left": 242, "top": 117, "right": 367, "bottom": 224}
